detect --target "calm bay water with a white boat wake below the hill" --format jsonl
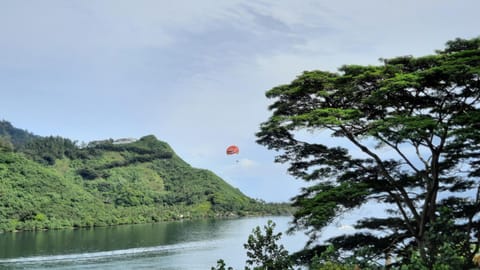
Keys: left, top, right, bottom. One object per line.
{"left": 0, "top": 217, "right": 306, "bottom": 270}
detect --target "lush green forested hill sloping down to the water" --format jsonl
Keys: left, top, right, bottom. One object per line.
{"left": 0, "top": 121, "right": 288, "bottom": 231}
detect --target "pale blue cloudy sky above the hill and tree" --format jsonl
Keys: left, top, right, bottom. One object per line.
{"left": 0, "top": 0, "right": 480, "bottom": 201}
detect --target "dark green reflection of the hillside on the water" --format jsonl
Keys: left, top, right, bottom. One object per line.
{"left": 0, "top": 220, "right": 228, "bottom": 258}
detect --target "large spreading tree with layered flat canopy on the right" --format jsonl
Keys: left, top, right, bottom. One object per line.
{"left": 256, "top": 38, "right": 480, "bottom": 269}
